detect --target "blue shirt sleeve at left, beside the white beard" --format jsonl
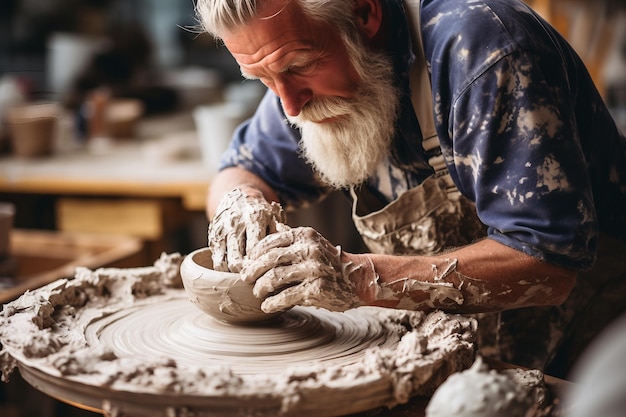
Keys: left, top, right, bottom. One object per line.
{"left": 220, "top": 90, "right": 328, "bottom": 209}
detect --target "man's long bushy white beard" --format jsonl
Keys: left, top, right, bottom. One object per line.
{"left": 288, "top": 47, "right": 399, "bottom": 189}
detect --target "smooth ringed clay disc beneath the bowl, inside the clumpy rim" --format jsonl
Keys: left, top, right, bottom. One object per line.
{"left": 85, "top": 297, "right": 400, "bottom": 374}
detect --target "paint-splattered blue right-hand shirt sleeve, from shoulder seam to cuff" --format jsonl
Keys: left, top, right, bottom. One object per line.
{"left": 438, "top": 51, "right": 597, "bottom": 269}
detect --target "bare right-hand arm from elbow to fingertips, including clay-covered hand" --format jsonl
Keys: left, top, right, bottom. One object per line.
{"left": 241, "top": 227, "right": 576, "bottom": 313}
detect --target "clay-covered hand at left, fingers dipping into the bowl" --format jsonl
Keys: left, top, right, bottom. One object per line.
{"left": 208, "top": 188, "right": 289, "bottom": 272}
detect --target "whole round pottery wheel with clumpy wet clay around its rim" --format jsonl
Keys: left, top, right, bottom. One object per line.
{"left": 0, "top": 255, "right": 476, "bottom": 417}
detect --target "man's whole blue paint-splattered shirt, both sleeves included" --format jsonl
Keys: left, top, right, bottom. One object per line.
{"left": 222, "top": 0, "right": 626, "bottom": 269}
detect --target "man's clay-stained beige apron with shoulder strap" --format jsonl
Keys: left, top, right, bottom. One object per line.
{"left": 350, "top": 0, "right": 626, "bottom": 377}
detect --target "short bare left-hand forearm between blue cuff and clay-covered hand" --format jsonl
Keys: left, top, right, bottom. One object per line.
{"left": 206, "top": 167, "right": 278, "bottom": 219}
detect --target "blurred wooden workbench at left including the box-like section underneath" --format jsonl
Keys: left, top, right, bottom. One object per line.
{"left": 0, "top": 114, "right": 212, "bottom": 264}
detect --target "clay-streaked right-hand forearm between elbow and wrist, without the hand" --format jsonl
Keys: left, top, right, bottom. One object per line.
{"left": 344, "top": 239, "right": 576, "bottom": 313}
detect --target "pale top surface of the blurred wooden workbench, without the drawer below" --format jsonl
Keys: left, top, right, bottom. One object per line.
{"left": 0, "top": 111, "right": 211, "bottom": 210}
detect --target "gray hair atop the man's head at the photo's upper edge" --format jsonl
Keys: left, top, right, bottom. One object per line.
{"left": 195, "top": 0, "right": 355, "bottom": 38}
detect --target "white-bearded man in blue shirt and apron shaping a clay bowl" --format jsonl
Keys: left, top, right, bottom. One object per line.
{"left": 197, "top": 0, "right": 626, "bottom": 373}
